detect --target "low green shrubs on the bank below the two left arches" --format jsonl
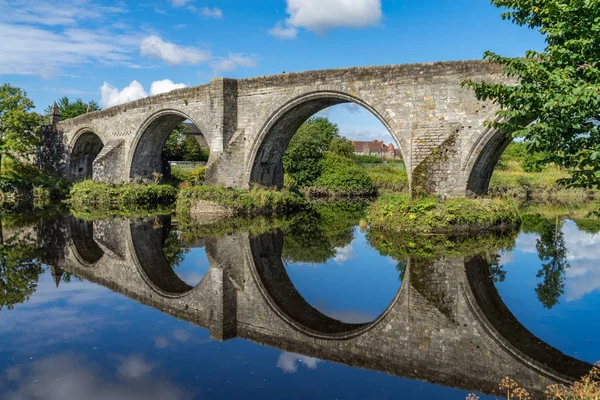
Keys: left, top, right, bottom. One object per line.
{"left": 69, "top": 180, "right": 177, "bottom": 207}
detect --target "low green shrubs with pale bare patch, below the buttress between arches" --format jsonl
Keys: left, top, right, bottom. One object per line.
{"left": 177, "top": 186, "right": 307, "bottom": 220}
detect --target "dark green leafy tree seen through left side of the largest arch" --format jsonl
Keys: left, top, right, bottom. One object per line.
{"left": 283, "top": 117, "right": 339, "bottom": 186}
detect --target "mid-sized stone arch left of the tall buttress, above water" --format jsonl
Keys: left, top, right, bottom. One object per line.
{"left": 126, "top": 109, "right": 212, "bottom": 181}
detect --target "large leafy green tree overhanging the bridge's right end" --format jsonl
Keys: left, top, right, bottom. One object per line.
{"left": 463, "top": 0, "right": 600, "bottom": 188}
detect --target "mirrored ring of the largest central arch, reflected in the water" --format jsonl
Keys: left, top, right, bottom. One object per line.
{"left": 248, "top": 231, "right": 404, "bottom": 340}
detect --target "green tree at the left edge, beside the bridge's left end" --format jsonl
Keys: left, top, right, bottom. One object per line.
{"left": 0, "top": 83, "right": 40, "bottom": 172}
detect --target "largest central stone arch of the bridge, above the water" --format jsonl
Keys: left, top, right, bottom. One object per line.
{"left": 246, "top": 90, "right": 410, "bottom": 186}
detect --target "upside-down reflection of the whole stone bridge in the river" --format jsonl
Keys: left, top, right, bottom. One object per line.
{"left": 58, "top": 217, "right": 592, "bottom": 397}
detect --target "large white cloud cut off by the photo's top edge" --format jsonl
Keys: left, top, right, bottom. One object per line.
{"left": 269, "top": 0, "right": 383, "bottom": 39}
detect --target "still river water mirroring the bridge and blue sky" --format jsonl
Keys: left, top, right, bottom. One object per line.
{"left": 0, "top": 205, "right": 600, "bottom": 400}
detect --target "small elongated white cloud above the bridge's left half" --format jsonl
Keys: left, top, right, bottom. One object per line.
{"left": 140, "top": 35, "right": 211, "bottom": 65}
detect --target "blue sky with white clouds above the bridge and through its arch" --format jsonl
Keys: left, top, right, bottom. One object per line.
{"left": 0, "top": 0, "right": 543, "bottom": 142}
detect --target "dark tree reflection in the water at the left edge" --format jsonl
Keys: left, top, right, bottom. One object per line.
{"left": 0, "top": 231, "right": 44, "bottom": 310}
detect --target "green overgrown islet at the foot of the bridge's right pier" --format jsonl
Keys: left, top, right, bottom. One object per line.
{"left": 368, "top": 195, "right": 521, "bottom": 234}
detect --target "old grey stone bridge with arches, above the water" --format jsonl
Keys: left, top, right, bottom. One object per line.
{"left": 54, "top": 61, "right": 509, "bottom": 196}
